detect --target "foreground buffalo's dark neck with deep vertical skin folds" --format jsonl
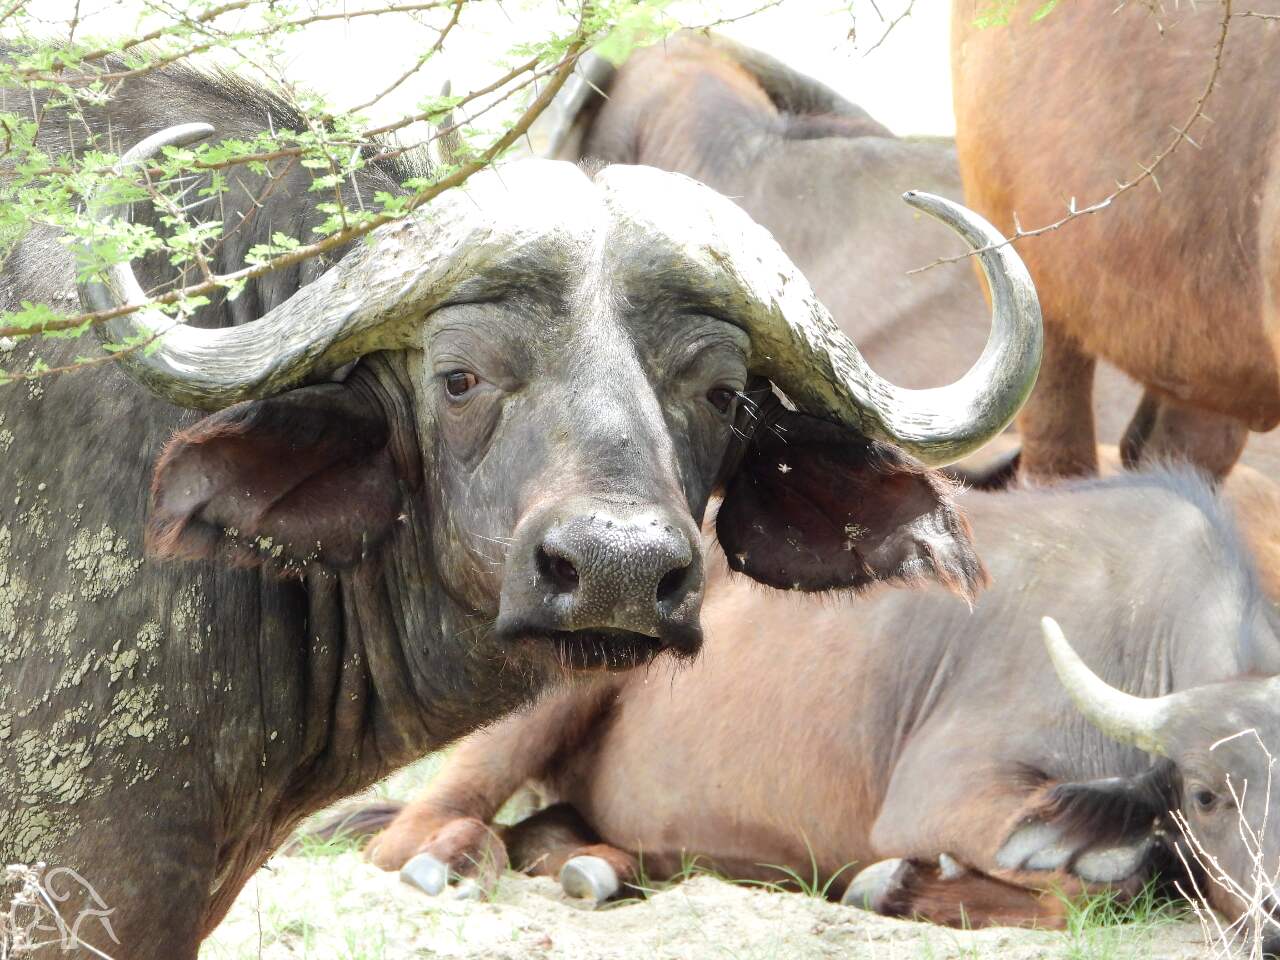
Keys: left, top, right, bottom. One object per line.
{"left": 209, "top": 522, "right": 538, "bottom": 928}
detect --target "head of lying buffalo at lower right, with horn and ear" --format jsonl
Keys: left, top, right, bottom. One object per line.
{"left": 1001, "top": 617, "right": 1280, "bottom": 955}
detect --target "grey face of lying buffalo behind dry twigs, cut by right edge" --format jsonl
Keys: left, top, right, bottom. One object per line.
{"left": 1166, "top": 680, "right": 1280, "bottom": 955}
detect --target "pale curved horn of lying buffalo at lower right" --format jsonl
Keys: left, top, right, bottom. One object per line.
{"left": 1041, "top": 617, "right": 1174, "bottom": 756}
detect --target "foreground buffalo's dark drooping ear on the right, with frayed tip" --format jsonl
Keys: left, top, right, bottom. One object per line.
{"left": 716, "top": 393, "right": 987, "bottom": 599}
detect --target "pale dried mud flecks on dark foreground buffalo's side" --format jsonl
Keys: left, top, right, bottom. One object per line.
{"left": 0, "top": 514, "right": 174, "bottom": 863}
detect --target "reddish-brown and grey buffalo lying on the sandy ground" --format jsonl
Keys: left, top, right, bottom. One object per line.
{"left": 332, "top": 470, "right": 1280, "bottom": 950}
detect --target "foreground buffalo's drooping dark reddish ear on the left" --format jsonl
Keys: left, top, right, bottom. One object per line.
{"left": 147, "top": 384, "right": 401, "bottom": 572}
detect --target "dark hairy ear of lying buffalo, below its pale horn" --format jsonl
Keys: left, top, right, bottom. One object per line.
{"left": 996, "top": 760, "right": 1178, "bottom": 883}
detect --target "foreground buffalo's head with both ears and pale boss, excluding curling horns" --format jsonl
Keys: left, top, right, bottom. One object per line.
{"left": 147, "top": 164, "right": 984, "bottom": 685}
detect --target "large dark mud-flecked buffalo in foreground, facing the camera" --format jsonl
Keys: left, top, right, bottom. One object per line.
{"left": 0, "top": 58, "right": 1039, "bottom": 960}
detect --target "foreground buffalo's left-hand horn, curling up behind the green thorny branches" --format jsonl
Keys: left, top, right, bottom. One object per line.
{"left": 78, "top": 124, "right": 576, "bottom": 410}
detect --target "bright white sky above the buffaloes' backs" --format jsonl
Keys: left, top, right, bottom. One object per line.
{"left": 28, "top": 0, "right": 954, "bottom": 134}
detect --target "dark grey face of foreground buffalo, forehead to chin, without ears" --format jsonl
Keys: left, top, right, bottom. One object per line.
{"left": 417, "top": 234, "right": 751, "bottom": 668}
